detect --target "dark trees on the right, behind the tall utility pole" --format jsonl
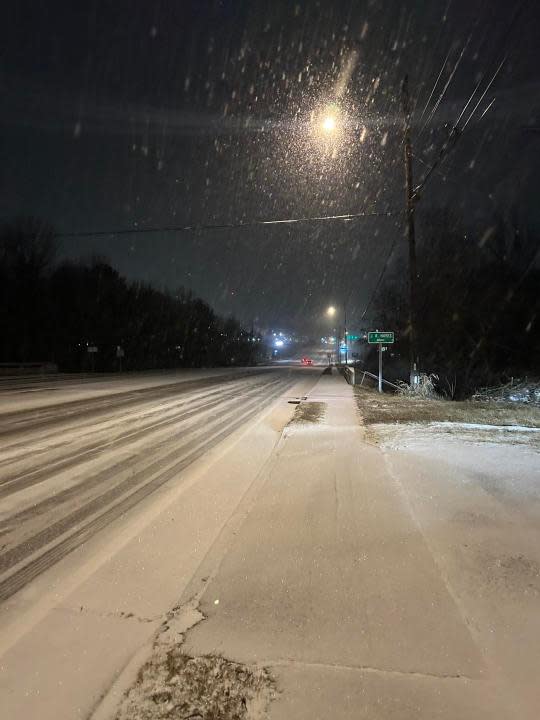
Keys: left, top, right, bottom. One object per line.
{"left": 375, "top": 209, "right": 540, "bottom": 398}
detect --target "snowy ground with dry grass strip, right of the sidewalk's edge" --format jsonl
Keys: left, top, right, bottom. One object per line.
{"left": 357, "top": 393, "right": 540, "bottom": 720}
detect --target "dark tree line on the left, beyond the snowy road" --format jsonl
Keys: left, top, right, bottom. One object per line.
{"left": 0, "top": 218, "right": 263, "bottom": 371}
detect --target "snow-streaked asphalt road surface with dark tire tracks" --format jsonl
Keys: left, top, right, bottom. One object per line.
{"left": 0, "top": 369, "right": 299, "bottom": 602}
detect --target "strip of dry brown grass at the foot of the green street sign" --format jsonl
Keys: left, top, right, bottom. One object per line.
{"left": 354, "top": 387, "right": 540, "bottom": 427}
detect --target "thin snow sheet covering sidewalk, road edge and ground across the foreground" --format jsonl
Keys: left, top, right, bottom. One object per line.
{"left": 4, "top": 375, "right": 540, "bottom": 720}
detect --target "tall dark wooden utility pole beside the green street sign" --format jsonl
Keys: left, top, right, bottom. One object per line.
{"left": 401, "top": 75, "right": 418, "bottom": 387}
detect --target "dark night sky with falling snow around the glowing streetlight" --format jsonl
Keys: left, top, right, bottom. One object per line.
{"left": 0, "top": 0, "right": 540, "bottom": 330}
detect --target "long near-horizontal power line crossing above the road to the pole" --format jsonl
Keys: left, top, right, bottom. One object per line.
{"left": 55, "top": 210, "right": 401, "bottom": 238}
